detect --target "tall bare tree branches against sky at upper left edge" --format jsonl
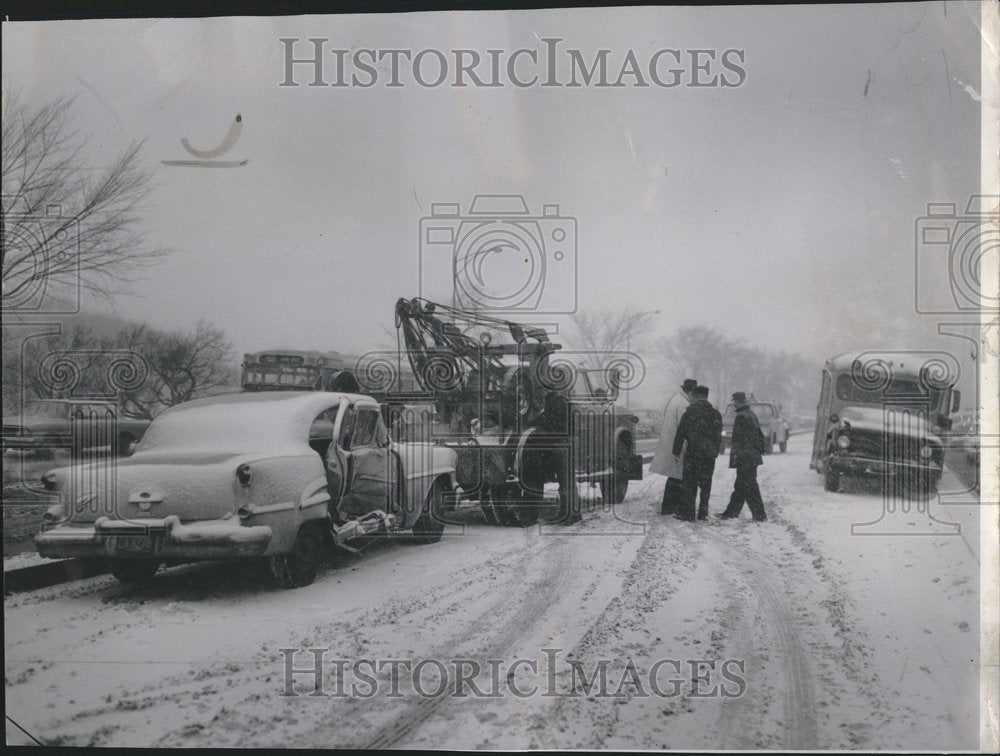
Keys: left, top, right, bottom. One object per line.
{"left": 0, "top": 95, "right": 166, "bottom": 307}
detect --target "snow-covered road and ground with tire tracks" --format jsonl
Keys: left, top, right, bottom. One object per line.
{"left": 4, "top": 435, "right": 979, "bottom": 750}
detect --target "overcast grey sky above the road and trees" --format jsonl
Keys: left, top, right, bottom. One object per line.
{"left": 3, "top": 2, "right": 982, "bottom": 404}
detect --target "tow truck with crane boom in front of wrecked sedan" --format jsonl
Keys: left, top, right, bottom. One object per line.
{"left": 385, "top": 297, "right": 642, "bottom": 527}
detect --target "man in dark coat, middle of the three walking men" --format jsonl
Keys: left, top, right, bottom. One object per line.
{"left": 673, "top": 386, "right": 722, "bottom": 520}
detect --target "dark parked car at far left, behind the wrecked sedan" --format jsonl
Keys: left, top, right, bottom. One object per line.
{"left": 3, "top": 399, "right": 150, "bottom": 459}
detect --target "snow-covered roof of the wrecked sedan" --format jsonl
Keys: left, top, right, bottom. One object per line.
{"left": 136, "top": 391, "right": 377, "bottom": 455}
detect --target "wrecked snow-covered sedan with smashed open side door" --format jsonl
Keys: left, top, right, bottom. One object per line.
{"left": 35, "top": 391, "right": 455, "bottom": 588}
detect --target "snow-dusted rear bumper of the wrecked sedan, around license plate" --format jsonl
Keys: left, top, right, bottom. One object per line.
{"left": 35, "top": 516, "right": 272, "bottom": 561}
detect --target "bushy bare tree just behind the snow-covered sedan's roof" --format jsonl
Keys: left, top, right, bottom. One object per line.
{"left": 117, "top": 322, "right": 235, "bottom": 418}
